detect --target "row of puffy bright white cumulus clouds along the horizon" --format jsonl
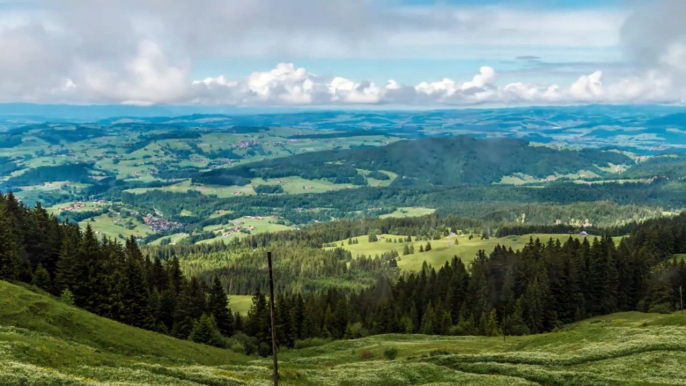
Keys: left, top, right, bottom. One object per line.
{"left": 184, "top": 63, "right": 678, "bottom": 106}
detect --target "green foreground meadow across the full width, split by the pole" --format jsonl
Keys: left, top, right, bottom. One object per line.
{"left": 6, "top": 281, "right": 686, "bottom": 386}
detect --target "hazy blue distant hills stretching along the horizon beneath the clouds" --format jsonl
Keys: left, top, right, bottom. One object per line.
{"left": 0, "top": 104, "right": 686, "bottom": 155}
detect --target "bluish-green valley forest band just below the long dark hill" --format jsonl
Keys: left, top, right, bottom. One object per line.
{"left": 110, "top": 179, "right": 686, "bottom": 231}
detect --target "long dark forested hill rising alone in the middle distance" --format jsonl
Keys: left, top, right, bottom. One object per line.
{"left": 194, "top": 135, "right": 631, "bottom": 186}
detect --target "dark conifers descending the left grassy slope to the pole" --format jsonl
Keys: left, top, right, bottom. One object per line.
{"left": 0, "top": 193, "right": 254, "bottom": 351}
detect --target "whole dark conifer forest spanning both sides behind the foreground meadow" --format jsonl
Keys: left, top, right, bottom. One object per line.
{"left": 0, "top": 194, "right": 686, "bottom": 355}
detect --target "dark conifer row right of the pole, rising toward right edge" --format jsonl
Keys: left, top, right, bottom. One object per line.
{"left": 234, "top": 215, "right": 686, "bottom": 347}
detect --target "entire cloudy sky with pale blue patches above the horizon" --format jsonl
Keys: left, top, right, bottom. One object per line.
{"left": 0, "top": 0, "right": 686, "bottom": 108}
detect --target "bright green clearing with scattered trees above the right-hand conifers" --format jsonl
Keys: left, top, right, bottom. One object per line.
{"left": 326, "top": 234, "right": 621, "bottom": 271}
